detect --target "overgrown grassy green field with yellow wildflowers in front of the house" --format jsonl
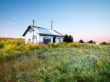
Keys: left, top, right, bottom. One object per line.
{"left": 0, "top": 39, "right": 110, "bottom": 82}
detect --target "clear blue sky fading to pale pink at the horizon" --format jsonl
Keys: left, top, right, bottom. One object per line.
{"left": 0, "top": 0, "right": 110, "bottom": 42}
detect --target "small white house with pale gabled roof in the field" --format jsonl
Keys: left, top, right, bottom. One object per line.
{"left": 23, "top": 25, "right": 63, "bottom": 44}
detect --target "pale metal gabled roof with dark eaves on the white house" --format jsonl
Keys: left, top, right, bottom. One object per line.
{"left": 23, "top": 26, "right": 63, "bottom": 36}
